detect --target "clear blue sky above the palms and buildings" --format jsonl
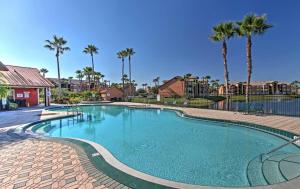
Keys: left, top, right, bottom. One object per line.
{"left": 0, "top": 0, "right": 300, "bottom": 84}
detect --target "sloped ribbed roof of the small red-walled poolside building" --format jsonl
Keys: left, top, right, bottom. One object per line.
{"left": 0, "top": 65, "right": 54, "bottom": 87}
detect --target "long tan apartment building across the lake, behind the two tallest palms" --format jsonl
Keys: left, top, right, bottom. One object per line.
{"left": 219, "top": 81, "right": 293, "bottom": 95}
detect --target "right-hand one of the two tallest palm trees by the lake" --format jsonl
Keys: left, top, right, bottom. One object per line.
{"left": 236, "top": 14, "right": 272, "bottom": 102}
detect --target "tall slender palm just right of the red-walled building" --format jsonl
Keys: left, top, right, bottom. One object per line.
{"left": 44, "top": 35, "right": 71, "bottom": 98}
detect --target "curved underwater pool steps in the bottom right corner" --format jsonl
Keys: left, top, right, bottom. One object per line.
{"left": 247, "top": 153, "right": 300, "bottom": 186}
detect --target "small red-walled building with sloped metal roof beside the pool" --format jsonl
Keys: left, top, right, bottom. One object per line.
{"left": 0, "top": 63, "right": 54, "bottom": 107}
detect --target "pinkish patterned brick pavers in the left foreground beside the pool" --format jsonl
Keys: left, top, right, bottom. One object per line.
{"left": 0, "top": 132, "right": 128, "bottom": 189}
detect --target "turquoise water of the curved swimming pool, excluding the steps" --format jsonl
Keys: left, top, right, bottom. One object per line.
{"left": 32, "top": 106, "right": 299, "bottom": 186}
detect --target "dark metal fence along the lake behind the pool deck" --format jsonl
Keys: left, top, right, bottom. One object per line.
{"left": 130, "top": 95, "right": 300, "bottom": 117}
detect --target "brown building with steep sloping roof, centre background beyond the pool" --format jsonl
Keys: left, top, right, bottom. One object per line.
{"left": 158, "top": 76, "right": 209, "bottom": 98}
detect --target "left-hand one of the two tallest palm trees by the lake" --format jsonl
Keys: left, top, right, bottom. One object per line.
{"left": 210, "top": 22, "right": 235, "bottom": 96}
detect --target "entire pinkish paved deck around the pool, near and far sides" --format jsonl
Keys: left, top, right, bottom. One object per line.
{"left": 0, "top": 102, "right": 300, "bottom": 189}
